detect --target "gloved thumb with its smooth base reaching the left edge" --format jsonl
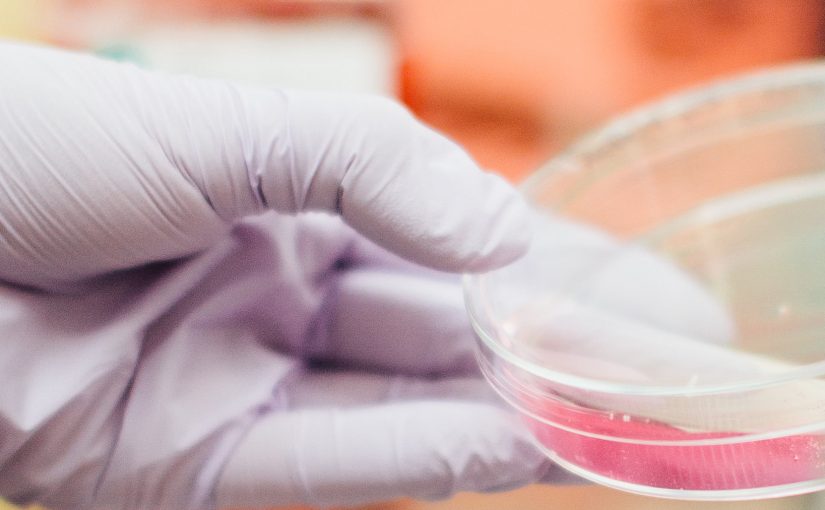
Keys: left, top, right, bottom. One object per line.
{"left": 0, "top": 44, "right": 529, "bottom": 286}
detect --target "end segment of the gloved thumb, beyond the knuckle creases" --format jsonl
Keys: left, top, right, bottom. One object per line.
{"left": 339, "top": 109, "right": 533, "bottom": 273}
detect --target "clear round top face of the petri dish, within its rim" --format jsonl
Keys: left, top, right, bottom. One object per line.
{"left": 465, "top": 63, "right": 825, "bottom": 396}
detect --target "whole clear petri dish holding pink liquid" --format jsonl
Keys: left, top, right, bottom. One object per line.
{"left": 465, "top": 63, "right": 825, "bottom": 500}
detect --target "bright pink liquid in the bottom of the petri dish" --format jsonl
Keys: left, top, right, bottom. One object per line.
{"left": 523, "top": 392, "right": 825, "bottom": 491}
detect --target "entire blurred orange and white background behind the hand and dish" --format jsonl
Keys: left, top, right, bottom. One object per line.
{"left": 0, "top": 0, "right": 825, "bottom": 510}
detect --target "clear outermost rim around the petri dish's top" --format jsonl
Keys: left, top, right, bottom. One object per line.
{"left": 463, "top": 60, "right": 825, "bottom": 397}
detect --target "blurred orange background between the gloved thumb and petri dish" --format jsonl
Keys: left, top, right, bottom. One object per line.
{"left": 398, "top": 0, "right": 823, "bottom": 178}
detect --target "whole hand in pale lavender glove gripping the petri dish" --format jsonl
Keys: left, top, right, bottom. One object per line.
{"left": 0, "top": 40, "right": 557, "bottom": 510}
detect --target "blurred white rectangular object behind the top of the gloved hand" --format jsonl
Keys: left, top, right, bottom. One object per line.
{"left": 118, "top": 18, "right": 396, "bottom": 96}
